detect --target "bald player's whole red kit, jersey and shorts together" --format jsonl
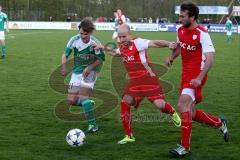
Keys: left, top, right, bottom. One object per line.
{"left": 115, "top": 38, "right": 164, "bottom": 102}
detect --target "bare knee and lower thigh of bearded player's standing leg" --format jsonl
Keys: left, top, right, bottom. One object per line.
{"left": 178, "top": 94, "right": 194, "bottom": 113}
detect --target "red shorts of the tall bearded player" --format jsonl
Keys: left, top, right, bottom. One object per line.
{"left": 179, "top": 76, "right": 207, "bottom": 104}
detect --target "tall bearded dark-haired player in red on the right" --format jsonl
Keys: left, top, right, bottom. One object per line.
{"left": 166, "top": 2, "right": 229, "bottom": 156}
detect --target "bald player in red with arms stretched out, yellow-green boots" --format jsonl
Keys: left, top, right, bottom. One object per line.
{"left": 94, "top": 24, "right": 181, "bottom": 144}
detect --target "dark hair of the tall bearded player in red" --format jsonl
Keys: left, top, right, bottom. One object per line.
{"left": 180, "top": 1, "right": 199, "bottom": 20}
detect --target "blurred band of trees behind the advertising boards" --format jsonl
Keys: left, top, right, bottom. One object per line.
{"left": 0, "top": 0, "right": 239, "bottom": 22}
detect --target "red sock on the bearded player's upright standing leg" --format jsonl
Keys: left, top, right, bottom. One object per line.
{"left": 181, "top": 112, "right": 192, "bottom": 150}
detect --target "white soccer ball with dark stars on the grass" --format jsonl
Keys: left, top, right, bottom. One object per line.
{"left": 66, "top": 129, "right": 86, "bottom": 147}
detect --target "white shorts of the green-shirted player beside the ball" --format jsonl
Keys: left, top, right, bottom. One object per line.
{"left": 68, "top": 71, "right": 97, "bottom": 93}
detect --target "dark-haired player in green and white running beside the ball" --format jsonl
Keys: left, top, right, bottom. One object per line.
{"left": 61, "top": 19, "right": 105, "bottom": 133}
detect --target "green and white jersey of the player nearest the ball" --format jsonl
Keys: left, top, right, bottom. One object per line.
{"left": 65, "top": 35, "right": 105, "bottom": 74}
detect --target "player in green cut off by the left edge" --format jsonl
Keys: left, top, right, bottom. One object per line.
{"left": 0, "top": 5, "right": 9, "bottom": 59}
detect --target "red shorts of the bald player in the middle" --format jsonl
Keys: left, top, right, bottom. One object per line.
{"left": 123, "top": 77, "right": 165, "bottom": 108}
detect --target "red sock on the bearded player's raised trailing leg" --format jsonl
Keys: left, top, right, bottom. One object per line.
{"left": 193, "top": 110, "right": 222, "bottom": 127}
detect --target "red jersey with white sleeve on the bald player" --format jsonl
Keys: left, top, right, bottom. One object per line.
{"left": 114, "top": 38, "right": 150, "bottom": 80}
